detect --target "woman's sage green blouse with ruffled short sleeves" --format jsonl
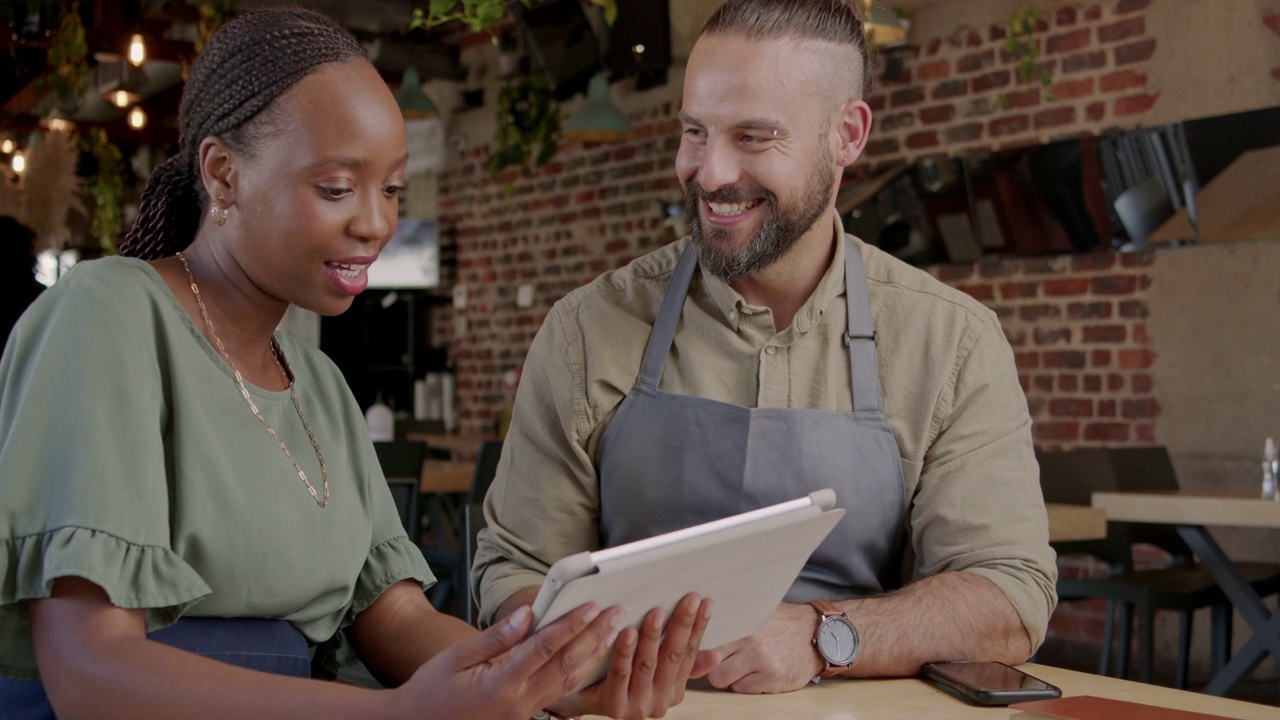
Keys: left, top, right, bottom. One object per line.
{"left": 0, "top": 258, "right": 434, "bottom": 679}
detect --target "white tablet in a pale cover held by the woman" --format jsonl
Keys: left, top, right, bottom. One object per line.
{"left": 532, "top": 489, "right": 845, "bottom": 688}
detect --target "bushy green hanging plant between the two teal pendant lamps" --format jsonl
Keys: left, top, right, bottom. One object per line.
{"left": 489, "top": 76, "right": 561, "bottom": 174}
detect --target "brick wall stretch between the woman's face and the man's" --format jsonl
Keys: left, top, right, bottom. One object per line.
{"left": 431, "top": 86, "right": 681, "bottom": 433}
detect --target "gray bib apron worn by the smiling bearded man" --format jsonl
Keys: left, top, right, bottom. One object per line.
{"left": 598, "top": 238, "right": 906, "bottom": 602}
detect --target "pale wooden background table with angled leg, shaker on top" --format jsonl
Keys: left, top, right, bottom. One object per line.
{"left": 1093, "top": 491, "right": 1280, "bottom": 694}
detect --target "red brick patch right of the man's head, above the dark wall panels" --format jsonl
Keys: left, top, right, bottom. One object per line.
{"left": 867, "top": 0, "right": 1161, "bottom": 164}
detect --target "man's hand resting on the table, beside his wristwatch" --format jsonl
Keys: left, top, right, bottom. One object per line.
{"left": 707, "top": 603, "right": 824, "bottom": 693}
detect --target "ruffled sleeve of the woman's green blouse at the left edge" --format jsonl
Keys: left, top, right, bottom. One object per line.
{"left": 0, "top": 260, "right": 210, "bottom": 678}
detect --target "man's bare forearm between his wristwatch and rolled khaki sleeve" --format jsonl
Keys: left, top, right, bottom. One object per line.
{"left": 836, "top": 573, "right": 1032, "bottom": 676}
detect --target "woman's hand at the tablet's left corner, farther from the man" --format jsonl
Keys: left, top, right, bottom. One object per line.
{"left": 393, "top": 605, "right": 622, "bottom": 720}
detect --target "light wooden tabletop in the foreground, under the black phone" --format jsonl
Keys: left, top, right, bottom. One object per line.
{"left": 583, "top": 665, "right": 1280, "bottom": 720}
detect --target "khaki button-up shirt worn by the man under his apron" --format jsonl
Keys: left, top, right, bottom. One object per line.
{"left": 472, "top": 227, "right": 1057, "bottom": 647}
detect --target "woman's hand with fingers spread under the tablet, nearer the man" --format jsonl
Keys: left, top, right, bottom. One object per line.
{"left": 550, "top": 593, "right": 719, "bottom": 719}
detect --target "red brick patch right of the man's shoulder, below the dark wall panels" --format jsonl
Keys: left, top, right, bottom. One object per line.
{"left": 931, "top": 251, "right": 1160, "bottom": 448}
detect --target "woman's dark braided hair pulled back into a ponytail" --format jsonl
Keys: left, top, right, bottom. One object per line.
{"left": 120, "top": 8, "right": 365, "bottom": 260}
